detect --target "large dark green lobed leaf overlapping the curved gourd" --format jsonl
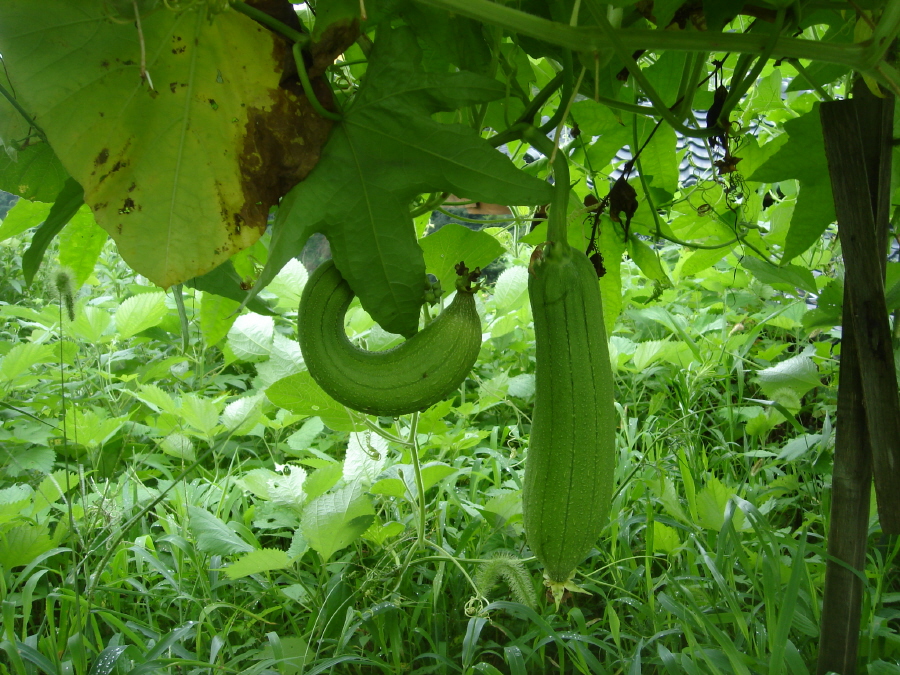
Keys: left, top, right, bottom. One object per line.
{"left": 257, "top": 27, "right": 550, "bottom": 336}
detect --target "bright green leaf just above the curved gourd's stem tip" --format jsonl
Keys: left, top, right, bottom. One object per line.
{"left": 419, "top": 223, "right": 503, "bottom": 295}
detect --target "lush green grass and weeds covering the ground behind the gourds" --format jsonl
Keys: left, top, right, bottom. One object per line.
{"left": 0, "top": 234, "right": 900, "bottom": 675}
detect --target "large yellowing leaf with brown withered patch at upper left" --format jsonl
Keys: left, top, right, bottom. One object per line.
{"left": 0, "top": 0, "right": 338, "bottom": 287}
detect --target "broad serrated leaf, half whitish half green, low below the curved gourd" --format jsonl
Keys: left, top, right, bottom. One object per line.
{"left": 300, "top": 485, "right": 375, "bottom": 562}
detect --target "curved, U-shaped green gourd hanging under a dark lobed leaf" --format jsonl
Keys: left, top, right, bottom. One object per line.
{"left": 298, "top": 261, "right": 481, "bottom": 417}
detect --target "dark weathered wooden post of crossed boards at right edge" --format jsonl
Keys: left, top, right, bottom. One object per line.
{"left": 817, "top": 86, "right": 900, "bottom": 675}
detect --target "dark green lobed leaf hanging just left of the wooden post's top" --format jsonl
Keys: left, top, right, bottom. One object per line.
{"left": 748, "top": 104, "right": 835, "bottom": 262}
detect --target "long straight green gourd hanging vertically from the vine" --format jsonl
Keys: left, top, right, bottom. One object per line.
{"left": 522, "top": 243, "right": 616, "bottom": 582}
